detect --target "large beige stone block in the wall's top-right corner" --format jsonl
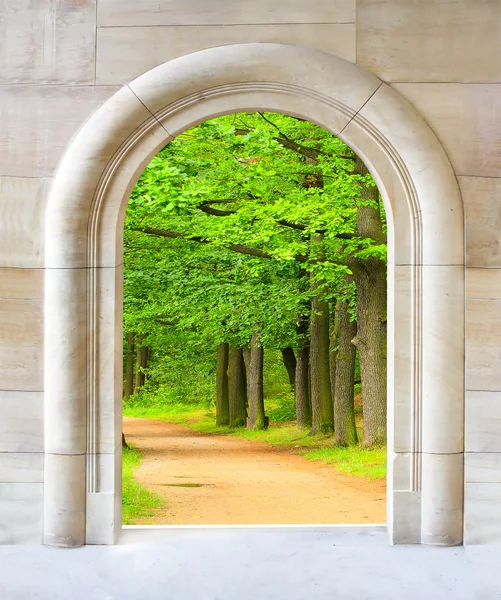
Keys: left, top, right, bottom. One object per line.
{"left": 357, "top": 0, "right": 501, "bottom": 83}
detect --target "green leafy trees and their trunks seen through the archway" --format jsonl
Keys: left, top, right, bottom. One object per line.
{"left": 124, "top": 113, "right": 387, "bottom": 448}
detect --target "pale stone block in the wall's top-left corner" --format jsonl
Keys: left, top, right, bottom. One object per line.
{"left": 0, "top": 0, "right": 96, "bottom": 84}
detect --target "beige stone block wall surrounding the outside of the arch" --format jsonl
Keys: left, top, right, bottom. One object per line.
{"left": 0, "top": 0, "right": 501, "bottom": 543}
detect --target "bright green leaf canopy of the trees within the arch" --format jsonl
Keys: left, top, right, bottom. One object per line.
{"left": 124, "top": 113, "right": 386, "bottom": 396}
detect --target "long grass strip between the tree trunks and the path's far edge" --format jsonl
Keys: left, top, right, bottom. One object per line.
{"left": 124, "top": 402, "right": 386, "bottom": 480}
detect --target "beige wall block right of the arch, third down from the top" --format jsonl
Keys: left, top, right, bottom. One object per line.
{"left": 459, "top": 177, "right": 501, "bottom": 268}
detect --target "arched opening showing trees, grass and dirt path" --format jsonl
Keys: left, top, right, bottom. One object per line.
{"left": 122, "top": 112, "right": 387, "bottom": 525}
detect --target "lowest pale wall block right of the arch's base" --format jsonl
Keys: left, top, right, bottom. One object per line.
{"left": 464, "top": 483, "right": 501, "bottom": 545}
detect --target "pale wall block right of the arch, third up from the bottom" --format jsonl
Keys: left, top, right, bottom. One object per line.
{"left": 465, "top": 391, "right": 501, "bottom": 452}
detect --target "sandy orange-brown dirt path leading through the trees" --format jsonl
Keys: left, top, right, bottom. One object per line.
{"left": 123, "top": 418, "right": 386, "bottom": 525}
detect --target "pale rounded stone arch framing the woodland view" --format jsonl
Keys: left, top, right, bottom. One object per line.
{"left": 44, "top": 44, "right": 464, "bottom": 546}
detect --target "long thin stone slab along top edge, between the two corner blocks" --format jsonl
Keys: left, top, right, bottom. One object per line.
{"left": 97, "top": 0, "right": 356, "bottom": 27}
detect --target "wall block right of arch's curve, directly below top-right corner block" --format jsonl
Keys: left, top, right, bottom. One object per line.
{"left": 392, "top": 83, "right": 501, "bottom": 177}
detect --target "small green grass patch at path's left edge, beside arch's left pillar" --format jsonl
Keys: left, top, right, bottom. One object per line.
{"left": 122, "top": 446, "right": 163, "bottom": 525}
